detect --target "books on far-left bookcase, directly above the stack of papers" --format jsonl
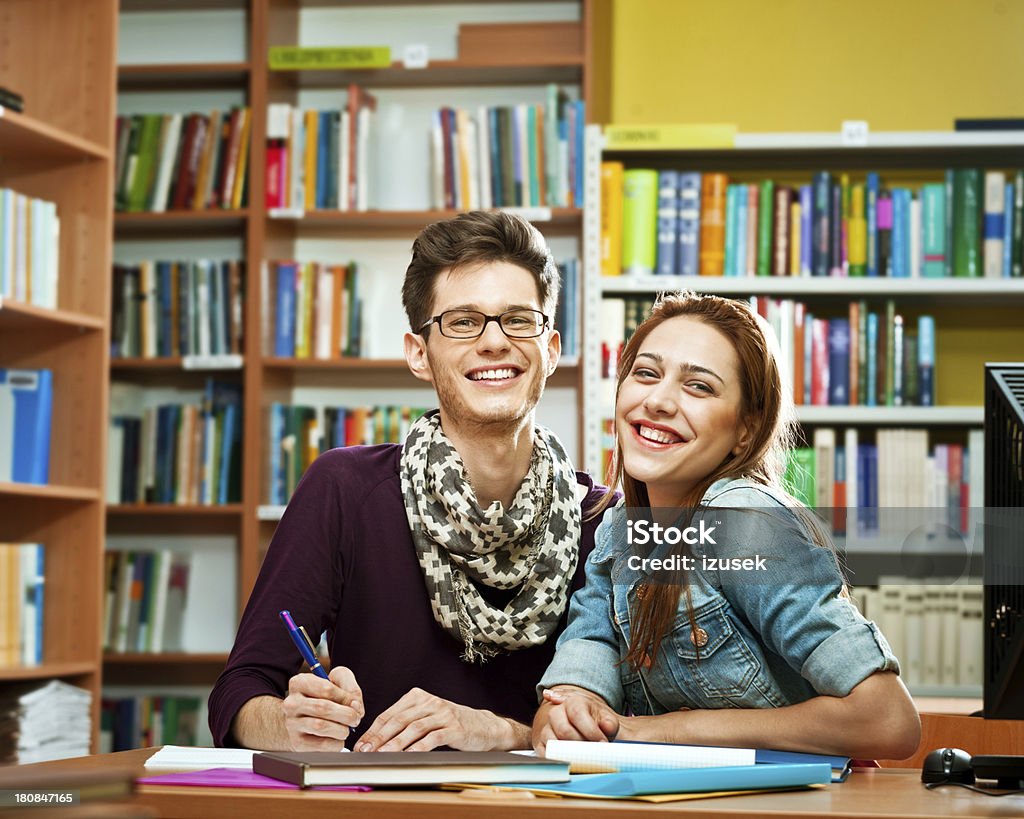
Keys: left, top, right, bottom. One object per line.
{"left": 0, "top": 544, "right": 46, "bottom": 667}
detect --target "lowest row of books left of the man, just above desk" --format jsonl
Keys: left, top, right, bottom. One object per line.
{"left": 99, "top": 696, "right": 202, "bottom": 753}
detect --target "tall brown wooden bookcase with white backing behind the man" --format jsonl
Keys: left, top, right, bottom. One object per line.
{"left": 100, "top": 0, "right": 607, "bottom": 749}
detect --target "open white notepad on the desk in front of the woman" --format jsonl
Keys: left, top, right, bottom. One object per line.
{"left": 544, "top": 739, "right": 754, "bottom": 774}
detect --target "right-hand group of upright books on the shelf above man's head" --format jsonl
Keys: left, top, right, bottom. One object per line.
{"left": 430, "top": 85, "right": 586, "bottom": 210}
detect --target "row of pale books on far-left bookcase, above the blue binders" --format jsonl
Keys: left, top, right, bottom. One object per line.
{"left": 0, "top": 187, "right": 60, "bottom": 309}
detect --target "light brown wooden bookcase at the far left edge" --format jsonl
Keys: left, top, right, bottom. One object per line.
{"left": 0, "top": 0, "right": 117, "bottom": 748}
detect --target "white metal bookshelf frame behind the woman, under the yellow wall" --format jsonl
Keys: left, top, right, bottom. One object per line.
{"left": 583, "top": 131, "right": 1024, "bottom": 697}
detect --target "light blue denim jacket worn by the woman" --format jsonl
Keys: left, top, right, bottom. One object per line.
{"left": 538, "top": 479, "right": 899, "bottom": 715}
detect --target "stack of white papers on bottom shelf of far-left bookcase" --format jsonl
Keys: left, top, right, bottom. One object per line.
{"left": 0, "top": 680, "right": 92, "bottom": 765}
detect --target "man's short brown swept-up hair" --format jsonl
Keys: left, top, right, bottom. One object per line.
{"left": 401, "top": 211, "right": 560, "bottom": 333}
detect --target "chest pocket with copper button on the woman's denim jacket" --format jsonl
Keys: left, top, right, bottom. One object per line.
{"left": 666, "top": 602, "right": 761, "bottom": 706}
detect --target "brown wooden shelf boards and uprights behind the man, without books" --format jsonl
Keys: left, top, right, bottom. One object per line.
{"left": 100, "top": 0, "right": 593, "bottom": 720}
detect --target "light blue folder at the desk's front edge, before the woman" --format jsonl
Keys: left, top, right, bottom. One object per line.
{"left": 501, "top": 762, "right": 833, "bottom": 799}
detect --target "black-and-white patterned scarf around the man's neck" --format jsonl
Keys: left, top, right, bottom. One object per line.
{"left": 400, "top": 410, "right": 582, "bottom": 662}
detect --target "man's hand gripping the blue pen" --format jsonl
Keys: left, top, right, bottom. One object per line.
{"left": 282, "top": 665, "right": 364, "bottom": 750}
